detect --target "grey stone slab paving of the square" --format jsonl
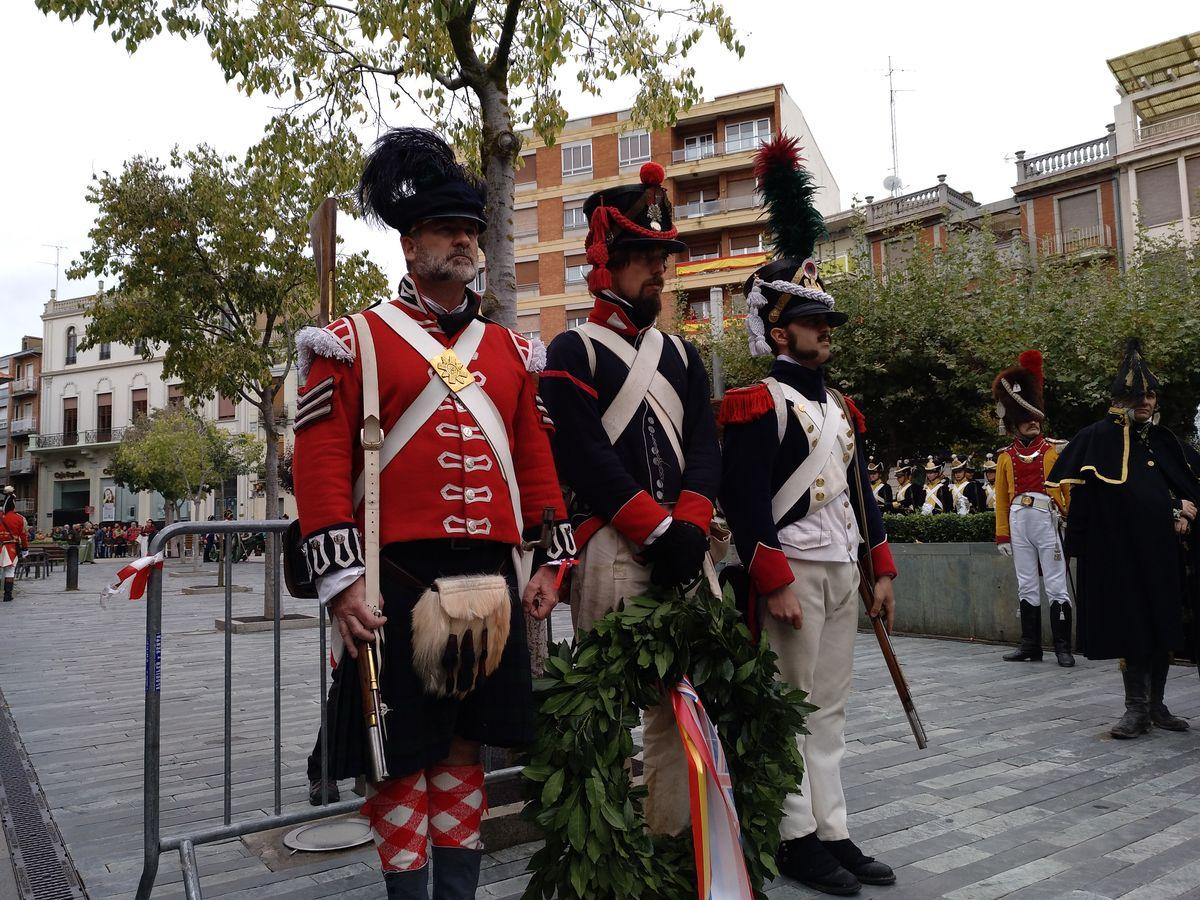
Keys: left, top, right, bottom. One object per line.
{"left": 0, "top": 559, "right": 1200, "bottom": 900}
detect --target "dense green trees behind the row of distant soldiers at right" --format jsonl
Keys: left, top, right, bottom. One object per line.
{"left": 703, "top": 223, "right": 1200, "bottom": 461}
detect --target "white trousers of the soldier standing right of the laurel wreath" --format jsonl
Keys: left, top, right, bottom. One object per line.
{"left": 764, "top": 559, "right": 859, "bottom": 841}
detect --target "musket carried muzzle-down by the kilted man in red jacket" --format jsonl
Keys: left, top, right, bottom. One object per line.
{"left": 308, "top": 197, "right": 389, "bottom": 781}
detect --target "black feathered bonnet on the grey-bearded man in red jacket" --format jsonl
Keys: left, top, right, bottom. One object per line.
{"left": 359, "top": 128, "right": 487, "bottom": 234}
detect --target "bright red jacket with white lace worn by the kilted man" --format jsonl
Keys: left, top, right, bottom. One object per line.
{"left": 293, "top": 278, "right": 575, "bottom": 576}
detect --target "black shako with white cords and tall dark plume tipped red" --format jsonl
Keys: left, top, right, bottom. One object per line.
{"left": 743, "top": 134, "right": 848, "bottom": 356}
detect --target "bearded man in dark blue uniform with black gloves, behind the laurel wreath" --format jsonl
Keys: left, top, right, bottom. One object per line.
{"left": 541, "top": 163, "right": 720, "bottom": 834}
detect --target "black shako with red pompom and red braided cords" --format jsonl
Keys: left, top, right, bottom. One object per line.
{"left": 583, "top": 162, "right": 688, "bottom": 294}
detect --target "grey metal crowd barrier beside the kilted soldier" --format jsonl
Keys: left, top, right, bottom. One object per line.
{"left": 137, "top": 520, "right": 520, "bottom": 900}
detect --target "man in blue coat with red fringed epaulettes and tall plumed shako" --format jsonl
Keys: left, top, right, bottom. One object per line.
{"left": 720, "top": 137, "right": 896, "bottom": 895}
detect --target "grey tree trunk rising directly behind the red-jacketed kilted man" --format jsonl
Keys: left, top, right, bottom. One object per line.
{"left": 476, "top": 82, "right": 521, "bottom": 329}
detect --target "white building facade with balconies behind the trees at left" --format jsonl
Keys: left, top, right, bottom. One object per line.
{"left": 30, "top": 296, "right": 296, "bottom": 530}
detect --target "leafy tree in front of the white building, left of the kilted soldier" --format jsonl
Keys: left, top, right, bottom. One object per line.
{"left": 71, "top": 119, "right": 386, "bottom": 549}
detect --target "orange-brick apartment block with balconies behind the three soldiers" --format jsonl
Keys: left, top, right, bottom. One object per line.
{"left": 512, "top": 85, "right": 841, "bottom": 342}
